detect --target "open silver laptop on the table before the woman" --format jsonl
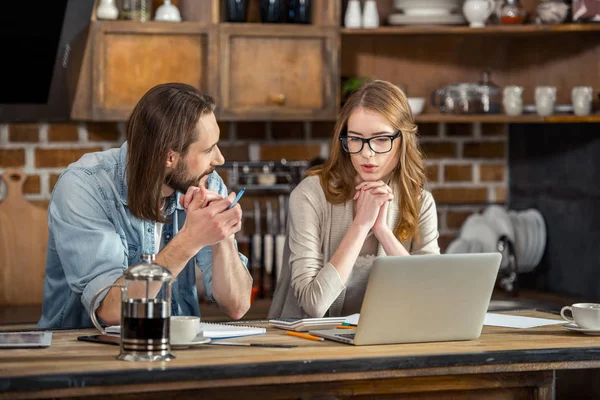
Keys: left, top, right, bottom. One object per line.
{"left": 309, "top": 253, "right": 502, "bottom": 346}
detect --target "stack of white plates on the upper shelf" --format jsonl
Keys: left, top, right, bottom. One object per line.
{"left": 389, "top": 0, "right": 466, "bottom": 25}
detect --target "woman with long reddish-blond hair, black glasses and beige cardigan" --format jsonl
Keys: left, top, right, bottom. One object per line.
{"left": 269, "top": 81, "right": 440, "bottom": 318}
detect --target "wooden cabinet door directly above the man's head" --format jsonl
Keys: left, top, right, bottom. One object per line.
{"left": 92, "top": 21, "right": 217, "bottom": 121}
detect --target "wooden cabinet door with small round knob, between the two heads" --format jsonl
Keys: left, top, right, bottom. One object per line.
{"left": 220, "top": 24, "right": 339, "bottom": 120}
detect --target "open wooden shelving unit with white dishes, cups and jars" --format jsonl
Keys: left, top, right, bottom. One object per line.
{"left": 340, "top": 0, "right": 600, "bottom": 123}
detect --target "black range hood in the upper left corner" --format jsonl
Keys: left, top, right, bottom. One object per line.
{"left": 0, "top": 0, "right": 94, "bottom": 123}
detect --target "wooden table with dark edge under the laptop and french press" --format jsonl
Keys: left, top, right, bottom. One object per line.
{"left": 0, "top": 312, "right": 600, "bottom": 400}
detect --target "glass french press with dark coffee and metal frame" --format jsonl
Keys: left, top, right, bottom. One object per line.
{"left": 90, "top": 254, "right": 175, "bottom": 361}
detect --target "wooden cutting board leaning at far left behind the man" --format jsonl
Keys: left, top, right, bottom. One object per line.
{"left": 0, "top": 170, "right": 48, "bottom": 306}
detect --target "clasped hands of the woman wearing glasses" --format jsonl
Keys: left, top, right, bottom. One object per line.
{"left": 354, "top": 181, "right": 394, "bottom": 231}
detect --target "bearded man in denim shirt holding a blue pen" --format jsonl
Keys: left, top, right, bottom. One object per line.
{"left": 38, "top": 83, "right": 252, "bottom": 329}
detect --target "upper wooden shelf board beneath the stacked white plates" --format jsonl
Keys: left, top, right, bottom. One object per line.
{"left": 341, "top": 24, "right": 600, "bottom": 35}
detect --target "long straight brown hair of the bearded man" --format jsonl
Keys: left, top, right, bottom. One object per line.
{"left": 127, "top": 83, "right": 215, "bottom": 223}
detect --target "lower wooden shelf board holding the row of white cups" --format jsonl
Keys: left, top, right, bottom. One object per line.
{"left": 415, "top": 114, "right": 600, "bottom": 124}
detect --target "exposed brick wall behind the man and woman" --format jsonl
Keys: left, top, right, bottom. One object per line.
{"left": 0, "top": 122, "right": 507, "bottom": 248}
